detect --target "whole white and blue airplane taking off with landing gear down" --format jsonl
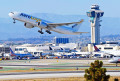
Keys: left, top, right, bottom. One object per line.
{"left": 9, "top": 12, "right": 88, "bottom": 35}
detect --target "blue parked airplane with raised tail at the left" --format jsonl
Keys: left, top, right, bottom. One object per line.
{"left": 10, "top": 48, "right": 33, "bottom": 60}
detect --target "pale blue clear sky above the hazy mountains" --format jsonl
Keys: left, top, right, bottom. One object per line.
{"left": 0, "top": 0, "right": 120, "bottom": 18}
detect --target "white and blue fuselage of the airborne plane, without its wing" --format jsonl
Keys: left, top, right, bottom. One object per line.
{"left": 9, "top": 12, "right": 80, "bottom": 35}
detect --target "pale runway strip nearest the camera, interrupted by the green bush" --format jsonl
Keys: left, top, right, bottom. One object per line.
{"left": 0, "top": 70, "right": 120, "bottom": 80}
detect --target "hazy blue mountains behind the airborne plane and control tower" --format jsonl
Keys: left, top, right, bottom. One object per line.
{"left": 0, "top": 13, "right": 120, "bottom": 40}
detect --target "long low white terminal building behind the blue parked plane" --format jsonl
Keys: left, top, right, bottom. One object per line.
{"left": 15, "top": 43, "right": 78, "bottom": 56}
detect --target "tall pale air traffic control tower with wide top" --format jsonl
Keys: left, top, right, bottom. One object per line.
{"left": 87, "top": 5, "right": 104, "bottom": 45}
